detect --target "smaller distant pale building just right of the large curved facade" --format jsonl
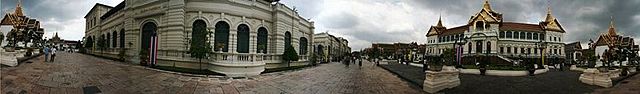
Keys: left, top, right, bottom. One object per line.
{"left": 313, "top": 32, "right": 351, "bottom": 62}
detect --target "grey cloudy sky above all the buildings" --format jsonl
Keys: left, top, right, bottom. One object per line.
{"left": 0, "top": 0, "right": 640, "bottom": 50}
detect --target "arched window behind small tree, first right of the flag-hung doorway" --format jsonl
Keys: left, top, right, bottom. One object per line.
{"left": 190, "top": 20, "right": 209, "bottom": 52}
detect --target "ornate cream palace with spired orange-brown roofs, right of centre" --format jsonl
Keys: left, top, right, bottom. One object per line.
{"left": 426, "top": 1, "right": 565, "bottom": 64}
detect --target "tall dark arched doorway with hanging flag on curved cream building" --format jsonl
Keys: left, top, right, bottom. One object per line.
{"left": 140, "top": 22, "right": 158, "bottom": 65}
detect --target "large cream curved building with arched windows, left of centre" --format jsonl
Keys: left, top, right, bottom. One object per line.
{"left": 84, "top": 0, "right": 314, "bottom": 76}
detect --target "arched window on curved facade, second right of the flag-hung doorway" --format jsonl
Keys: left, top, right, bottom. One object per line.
{"left": 214, "top": 21, "right": 229, "bottom": 52}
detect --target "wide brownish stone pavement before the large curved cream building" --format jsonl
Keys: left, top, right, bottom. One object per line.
{"left": 0, "top": 52, "right": 423, "bottom": 94}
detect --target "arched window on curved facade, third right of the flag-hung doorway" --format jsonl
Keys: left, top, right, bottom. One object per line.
{"left": 236, "top": 24, "right": 249, "bottom": 53}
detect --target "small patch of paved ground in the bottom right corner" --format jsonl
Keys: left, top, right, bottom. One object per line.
{"left": 593, "top": 74, "right": 640, "bottom": 94}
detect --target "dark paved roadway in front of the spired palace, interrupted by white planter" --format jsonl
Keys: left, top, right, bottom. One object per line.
{"left": 381, "top": 63, "right": 604, "bottom": 94}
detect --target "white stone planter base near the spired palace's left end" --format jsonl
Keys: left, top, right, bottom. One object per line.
{"left": 422, "top": 66, "right": 460, "bottom": 93}
